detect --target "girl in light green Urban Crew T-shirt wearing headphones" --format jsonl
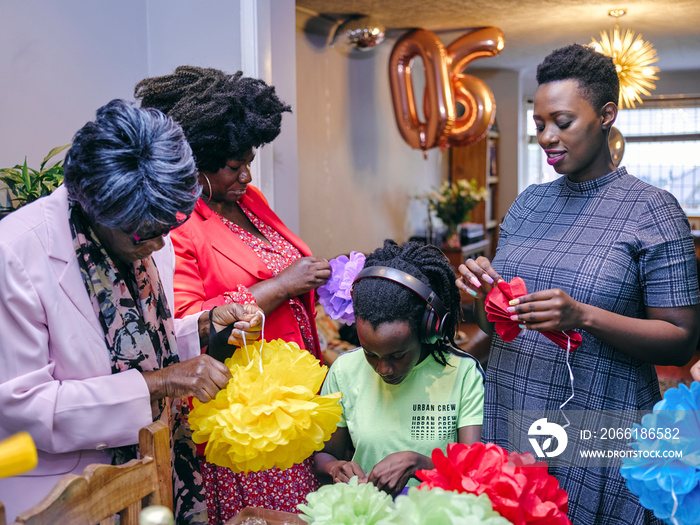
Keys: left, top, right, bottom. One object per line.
{"left": 315, "top": 240, "right": 484, "bottom": 496}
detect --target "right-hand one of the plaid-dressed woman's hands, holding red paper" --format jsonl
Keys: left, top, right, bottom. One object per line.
{"left": 508, "top": 288, "right": 584, "bottom": 332}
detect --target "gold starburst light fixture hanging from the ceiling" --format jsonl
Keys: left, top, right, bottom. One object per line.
{"left": 591, "top": 9, "right": 659, "bottom": 109}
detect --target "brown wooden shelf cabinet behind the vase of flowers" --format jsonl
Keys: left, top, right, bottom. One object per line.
{"left": 447, "top": 129, "right": 500, "bottom": 258}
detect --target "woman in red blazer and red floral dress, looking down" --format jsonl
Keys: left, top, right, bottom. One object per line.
{"left": 136, "top": 66, "right": 330, "bottom": 524}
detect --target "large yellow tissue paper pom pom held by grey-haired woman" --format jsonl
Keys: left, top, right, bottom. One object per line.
{"left": 189, "top": 339, "right": 342, "bottom": 473}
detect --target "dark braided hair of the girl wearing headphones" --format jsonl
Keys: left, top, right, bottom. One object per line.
{"left": 352, "top": 239, "right": 462, "bottom": 365}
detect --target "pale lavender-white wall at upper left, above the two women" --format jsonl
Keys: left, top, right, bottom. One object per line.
{"left": 0, "top": 0, "right": 249, "bottom": 186}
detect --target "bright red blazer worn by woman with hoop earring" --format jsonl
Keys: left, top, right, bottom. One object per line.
{"left": 170, "top": 185, "right": 322, "bottom": 360}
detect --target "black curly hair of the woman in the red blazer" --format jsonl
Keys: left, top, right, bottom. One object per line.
{"left": 134, "top": 66, "right": 291, "bottom": 173}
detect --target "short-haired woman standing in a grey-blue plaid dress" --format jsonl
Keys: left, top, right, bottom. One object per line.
{"left": 457, "top": 44, "right": 700, "bottom": 525}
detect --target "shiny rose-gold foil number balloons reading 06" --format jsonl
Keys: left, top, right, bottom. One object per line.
{"left": 389, "top": 27, "right": 505, "bottom": 153}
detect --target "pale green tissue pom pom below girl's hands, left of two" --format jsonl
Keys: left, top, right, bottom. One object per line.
{"left": 297, "top": 476, "right": 393, "bottom": 525}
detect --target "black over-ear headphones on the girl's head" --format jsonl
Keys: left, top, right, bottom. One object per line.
{"left": 352, "top": 266, "right": 450, "bottom": 345}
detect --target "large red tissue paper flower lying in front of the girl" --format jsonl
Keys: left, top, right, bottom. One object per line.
{"left": 416, "top": 443, "right": 571, "bottom": 525}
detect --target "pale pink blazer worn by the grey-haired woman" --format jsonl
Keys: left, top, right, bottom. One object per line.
{"left": 0, "top": 186, "right": 200, "bottom": 521}
